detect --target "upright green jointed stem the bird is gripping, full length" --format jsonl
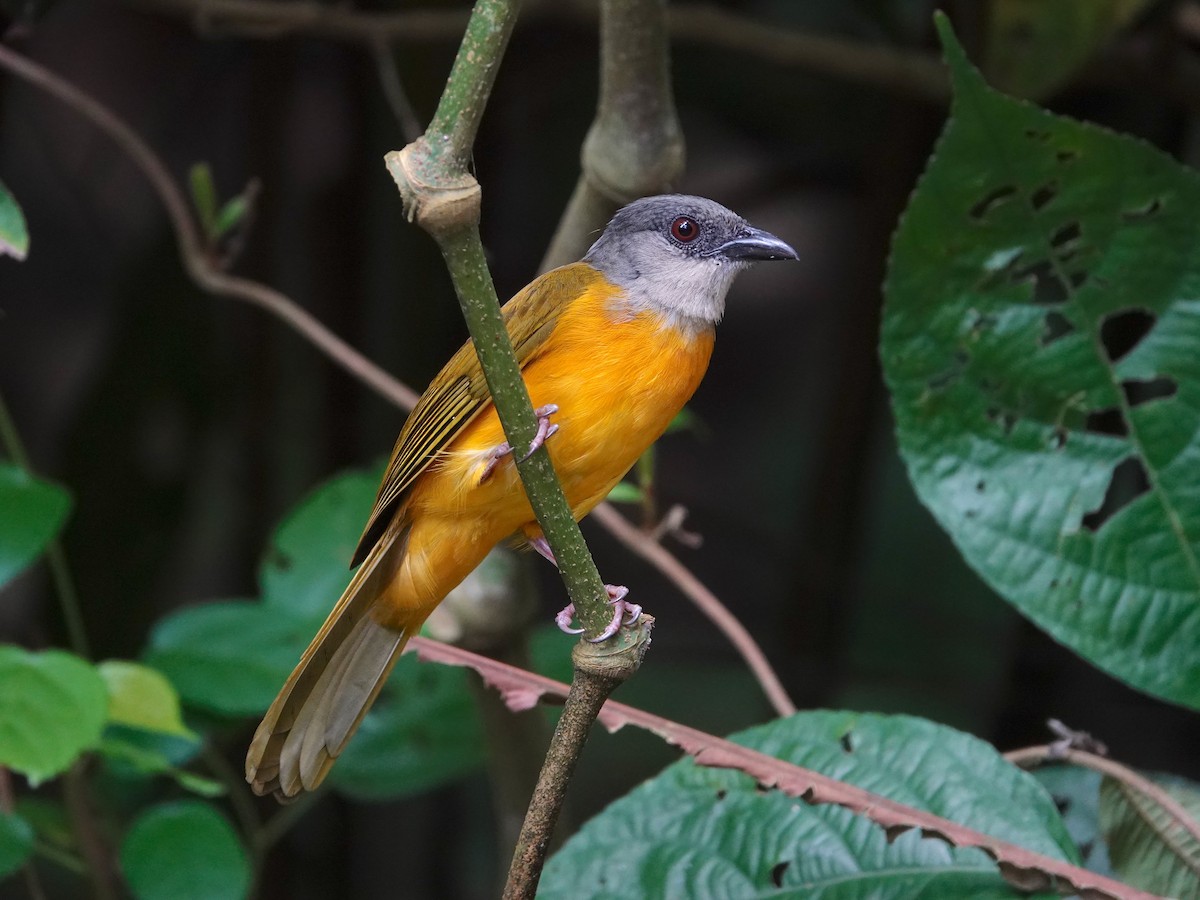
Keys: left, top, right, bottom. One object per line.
{"left": 386, "top": 0, "right": 652, "bottom": 898}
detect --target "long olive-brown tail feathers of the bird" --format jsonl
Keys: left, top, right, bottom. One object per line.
{"left": 246, "top": 529, "right": 425, "bottom": 800}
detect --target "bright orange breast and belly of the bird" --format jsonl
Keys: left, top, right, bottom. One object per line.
{"left": 409, "top": 275, "right": 714, "bottom": 540}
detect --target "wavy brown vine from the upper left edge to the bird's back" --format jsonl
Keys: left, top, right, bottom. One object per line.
{"left": 0, "top": 42, "right": 418, "bottom": 408}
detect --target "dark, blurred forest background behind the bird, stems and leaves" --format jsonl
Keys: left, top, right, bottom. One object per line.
{"left": 0, "top": 0, "right": 1200, "bottom": 898}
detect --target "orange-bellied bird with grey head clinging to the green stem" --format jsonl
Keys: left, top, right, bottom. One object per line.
{"left": 246, "top": 194, "right": 798, "bottom": 802}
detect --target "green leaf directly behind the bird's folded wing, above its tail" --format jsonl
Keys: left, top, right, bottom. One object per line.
{"left": 259, "top": 472, "right": 379, "bottom": 624}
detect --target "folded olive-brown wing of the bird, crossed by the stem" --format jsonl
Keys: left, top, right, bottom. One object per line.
{"left": 350, "top": 263, "right": 604, "bottom": 566}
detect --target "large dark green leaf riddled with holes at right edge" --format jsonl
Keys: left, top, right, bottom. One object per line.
{"left": 881, "top": 18, "right": 1200, "bottom": 707}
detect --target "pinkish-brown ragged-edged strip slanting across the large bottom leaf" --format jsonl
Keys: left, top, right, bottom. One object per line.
{"left": 409, "top": 637, "right": 1154, "bottom": 900}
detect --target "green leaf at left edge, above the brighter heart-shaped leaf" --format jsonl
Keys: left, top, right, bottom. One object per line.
{"left": 0, "top": 462, "right": 71, "bottom": 584}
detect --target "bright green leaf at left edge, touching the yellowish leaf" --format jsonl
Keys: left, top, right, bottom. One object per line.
{"left": 0, "top": 646, "right": 108, "bottom": 785}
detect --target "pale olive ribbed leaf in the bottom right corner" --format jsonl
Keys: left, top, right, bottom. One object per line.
{"left": 1100, "top": 775, "right": 1200, "bottom": 896}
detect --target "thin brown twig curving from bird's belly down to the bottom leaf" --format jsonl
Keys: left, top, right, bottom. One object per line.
{"left": 592, "top": 503, "right": 796, "bottom": 715}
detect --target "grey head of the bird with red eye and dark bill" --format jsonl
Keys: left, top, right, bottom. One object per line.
{"left": 583, "top": 194, "right": 797, "bottom": 330}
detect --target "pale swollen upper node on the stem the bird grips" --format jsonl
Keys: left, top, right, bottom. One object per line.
{"left": 384, "top": 146, "right": 482, "bottom": 234}
